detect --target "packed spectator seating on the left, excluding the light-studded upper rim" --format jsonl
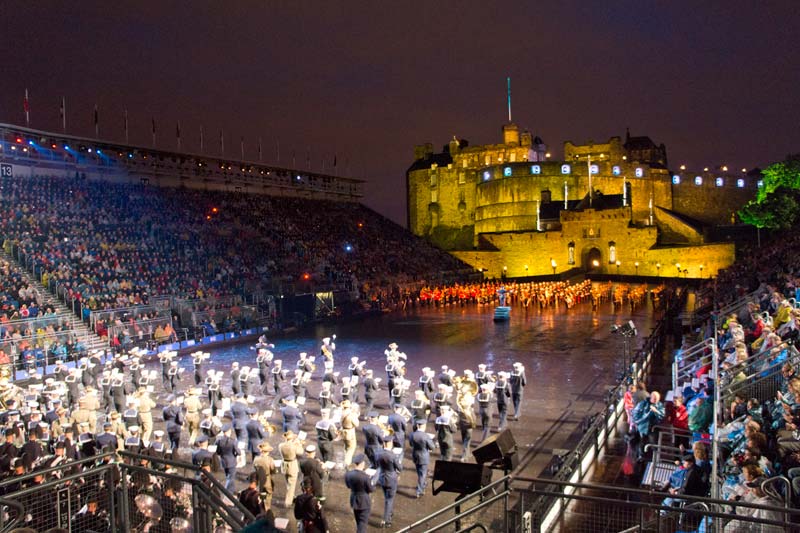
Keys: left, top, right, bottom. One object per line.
{"left": 0, "top": 177, "right": 464, "bottom": 309}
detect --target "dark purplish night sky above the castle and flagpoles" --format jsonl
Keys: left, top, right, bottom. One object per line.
{"left": 0, "top": 0, "right": 800, "bottom": 222}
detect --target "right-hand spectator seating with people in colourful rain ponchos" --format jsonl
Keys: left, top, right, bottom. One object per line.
{"left": 643, "top": 236, "right": 800, "bottom": 505}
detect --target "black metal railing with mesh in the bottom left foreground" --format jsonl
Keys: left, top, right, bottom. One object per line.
{"left": 0, "top": 452, "right": 254, "bottom": 533}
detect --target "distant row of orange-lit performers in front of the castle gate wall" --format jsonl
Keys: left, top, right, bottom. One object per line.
{"left": 415, "top": 279, "right": 664, "bottom": 310}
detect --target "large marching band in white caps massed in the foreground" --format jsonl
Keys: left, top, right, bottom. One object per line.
{"left": 0, "top": 336, "right": 526, "bottom": 531}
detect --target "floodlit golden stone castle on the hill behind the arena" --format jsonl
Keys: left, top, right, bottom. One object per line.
{"left": 406, "top": 123, "right": 761, "bottom": 278}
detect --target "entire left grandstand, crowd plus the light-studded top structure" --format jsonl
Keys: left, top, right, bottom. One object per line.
{"left": 0, "top": 125, "right": 472, "bottom": 366}
